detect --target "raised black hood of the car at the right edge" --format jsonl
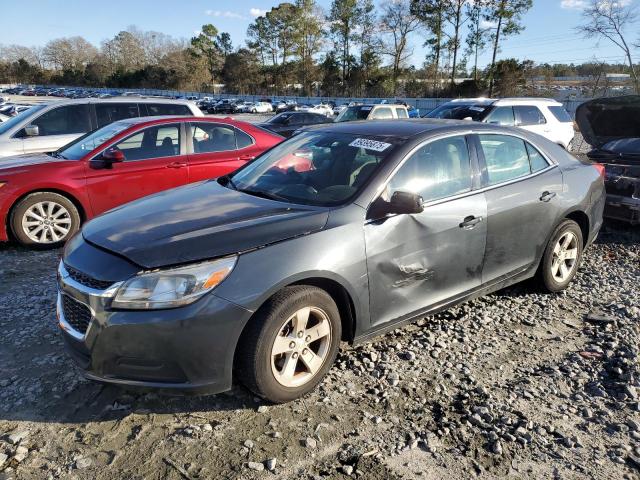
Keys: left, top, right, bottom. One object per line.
{"left": 576, "top": 95, "right": 640, "bottom": 150}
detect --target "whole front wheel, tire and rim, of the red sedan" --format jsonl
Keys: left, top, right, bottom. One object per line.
{"left": 10, "top": 192, "right": 81, "bottom": 248}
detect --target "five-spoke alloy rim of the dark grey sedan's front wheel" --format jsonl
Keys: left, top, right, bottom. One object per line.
{"left": 271, "top": 307, "right": 331, "bottom": 387}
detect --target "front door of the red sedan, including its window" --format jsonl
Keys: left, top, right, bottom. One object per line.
{"left": 87, "top": 122, "right": 189, "bottom": 215}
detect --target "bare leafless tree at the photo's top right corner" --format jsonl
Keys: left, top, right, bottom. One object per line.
{"left": 577, "top": 0, "right": 640, "bottom": 93}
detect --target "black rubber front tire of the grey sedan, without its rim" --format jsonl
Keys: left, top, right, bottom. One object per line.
{"left": 252, "top": 287, "right": 342, "bottom": 403}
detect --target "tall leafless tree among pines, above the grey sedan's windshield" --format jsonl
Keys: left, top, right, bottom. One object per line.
{"left": 381, "top": 0, "right": 420, "bottom": 93}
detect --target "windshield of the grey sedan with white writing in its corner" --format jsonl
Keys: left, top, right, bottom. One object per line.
{"left": 228, "top": 132, "right": 397, "bottom": 206}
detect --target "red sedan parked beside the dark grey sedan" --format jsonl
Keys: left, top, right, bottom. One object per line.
{"left": 0, "top": 117, "right": 282, "bottom": 246}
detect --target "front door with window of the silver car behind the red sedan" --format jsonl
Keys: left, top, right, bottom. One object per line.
{"left": 15, "top": 103, "right": 92, "bottom": 153}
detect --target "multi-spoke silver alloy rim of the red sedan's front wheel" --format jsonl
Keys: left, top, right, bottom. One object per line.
{"left": 22, "top": 201, "right": 71, "bottom": 244}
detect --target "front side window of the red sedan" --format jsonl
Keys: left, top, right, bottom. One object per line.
{"left": 113, "top": 124, "right": 180, "bottom": 161}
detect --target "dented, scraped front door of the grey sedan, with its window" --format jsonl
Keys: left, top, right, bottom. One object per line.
{"left": 364, "top": 135, "right": 487, "bottom": 327}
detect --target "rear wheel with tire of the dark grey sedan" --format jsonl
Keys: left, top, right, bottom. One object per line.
{"left": 538, "top": 220, "right": 584, "bottom": 292}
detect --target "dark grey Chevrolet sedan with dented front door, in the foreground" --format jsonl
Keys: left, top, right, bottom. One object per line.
{"left": 58, "top": 120, "right": 604, "bottom": 402}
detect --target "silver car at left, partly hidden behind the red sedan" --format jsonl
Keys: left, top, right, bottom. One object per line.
{"left": 0, "top": 98, "right": 203, "bottom": 157}
